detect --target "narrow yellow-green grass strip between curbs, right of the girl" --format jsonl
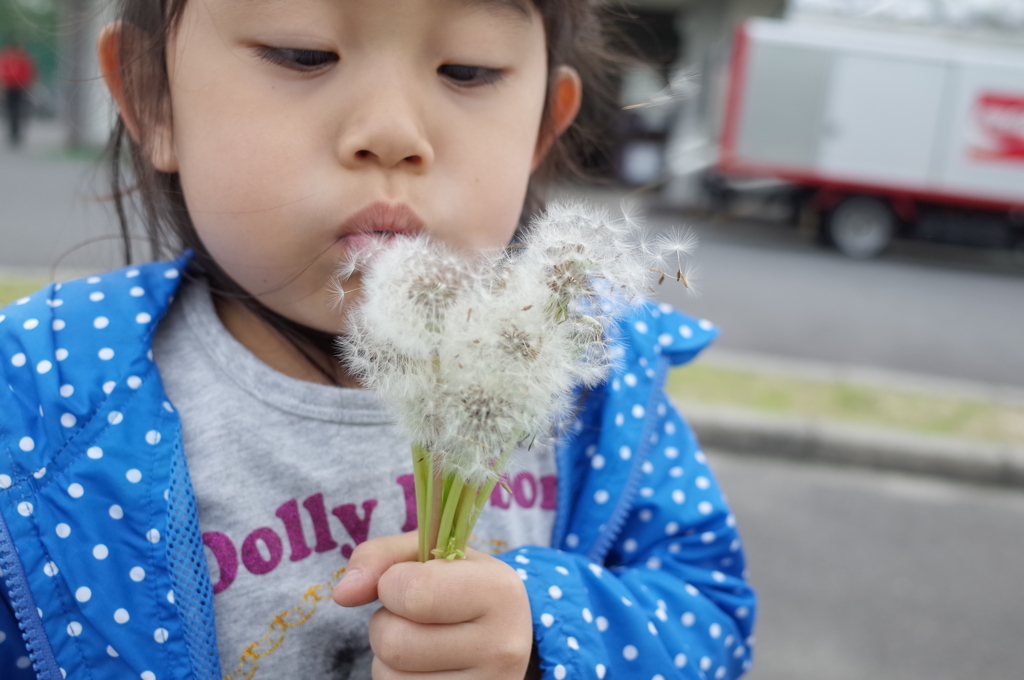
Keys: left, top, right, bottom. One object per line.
{"left": 667, "top": 364, "right": 1024, "bottom": 449}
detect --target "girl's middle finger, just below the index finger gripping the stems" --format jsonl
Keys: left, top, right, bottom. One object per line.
{"left": 370, "top": 609, "right": 483, "bottom": 678}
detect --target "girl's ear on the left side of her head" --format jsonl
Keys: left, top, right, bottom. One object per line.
{"left": 96, "top": 22, "right": 178, "bottom": 172}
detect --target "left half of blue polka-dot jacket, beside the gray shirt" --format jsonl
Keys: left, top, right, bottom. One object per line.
{"left": 0, "top": 263, "right": 188, "bottom": 680}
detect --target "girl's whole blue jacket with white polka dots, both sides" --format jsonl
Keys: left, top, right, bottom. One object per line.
{"left": 0, "top": 264, "right": 754, "bottom": 680}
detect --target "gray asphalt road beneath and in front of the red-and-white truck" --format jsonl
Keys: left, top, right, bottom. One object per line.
{"left": 651, "top": 216, "right": 1024, "bottom": 388}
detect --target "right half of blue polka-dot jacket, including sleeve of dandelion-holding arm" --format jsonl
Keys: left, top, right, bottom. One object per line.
{"left": 495, "top": 306, "right": 753, "bottom": 680}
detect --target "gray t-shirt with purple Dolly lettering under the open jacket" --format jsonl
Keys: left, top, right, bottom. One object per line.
{"left": 154, "top": 281, "right": 557, "bottom": 679}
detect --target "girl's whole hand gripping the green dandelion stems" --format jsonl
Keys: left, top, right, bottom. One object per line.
{"left": 334, "top": 532, "right": 534, "bottom": 680}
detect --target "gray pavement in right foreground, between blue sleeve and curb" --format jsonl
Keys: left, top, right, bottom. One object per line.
{"left": 709, "top": 452, "right": 1024, "bottom": 680}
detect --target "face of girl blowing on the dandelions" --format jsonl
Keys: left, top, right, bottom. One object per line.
{"left": 152, "top": 0, "right": 574, "bottom": 332}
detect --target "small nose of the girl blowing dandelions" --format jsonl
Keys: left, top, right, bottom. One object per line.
{"left": 338, "top": 83, "right": 434, "bottom": 172}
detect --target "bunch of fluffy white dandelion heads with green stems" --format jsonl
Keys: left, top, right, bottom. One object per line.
{"left": 339, "top": 203, "right": 695, "bottom": 561}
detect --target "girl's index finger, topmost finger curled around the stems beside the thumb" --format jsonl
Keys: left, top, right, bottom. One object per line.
{"left": 377, "top": 553, "right": 526, "bottom": 624}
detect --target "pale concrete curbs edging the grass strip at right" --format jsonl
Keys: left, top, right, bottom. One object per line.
{"left": 669, "top": 349, "right": 1024, "bottom": 487}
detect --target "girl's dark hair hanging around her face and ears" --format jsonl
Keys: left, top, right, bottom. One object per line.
{"left": 108, "top": 0, "right": 618, "bottom": 383}
